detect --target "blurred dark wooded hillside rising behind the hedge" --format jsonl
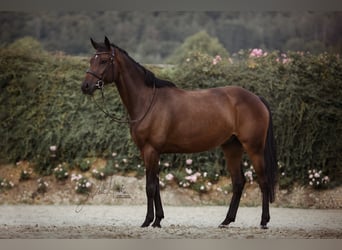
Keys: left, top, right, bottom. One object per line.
{"left": 0, "top": 11, "right": 342, "bottom": 63}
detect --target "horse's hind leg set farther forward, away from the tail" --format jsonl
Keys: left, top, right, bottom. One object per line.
{"left": 219, "top": 136, "right": 246, "bottom": 228}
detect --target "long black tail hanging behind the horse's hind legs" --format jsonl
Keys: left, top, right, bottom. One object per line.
{"left": 260, "top": 97, "right": 278, "bottom": 203}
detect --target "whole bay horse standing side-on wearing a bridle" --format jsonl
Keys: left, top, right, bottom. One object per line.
{"left": 81, "top": 37, "right": 277, "bottom": 228}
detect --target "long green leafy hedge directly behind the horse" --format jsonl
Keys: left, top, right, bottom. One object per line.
{"left": 0, "top": 38, "right": 342, "bottom": 186}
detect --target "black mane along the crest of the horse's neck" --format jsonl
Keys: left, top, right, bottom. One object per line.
{"left": 103, "top": 44, "right": 177, "bottom": 88}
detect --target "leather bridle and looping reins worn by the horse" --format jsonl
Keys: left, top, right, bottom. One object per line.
{"left": 86, "top": 51, "right": 157, "bottom": 124}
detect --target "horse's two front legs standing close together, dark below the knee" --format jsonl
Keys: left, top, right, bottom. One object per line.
{"left": 141, "top": 146, "right": 164, "bottom": 227}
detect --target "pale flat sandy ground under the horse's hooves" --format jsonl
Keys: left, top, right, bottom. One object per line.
{"left": 0, "top": 205, "right": 342, "bottom": 239}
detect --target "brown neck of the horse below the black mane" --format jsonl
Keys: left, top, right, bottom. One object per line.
{"left": 116, "top": 53, "right": 152, "bottom": 120}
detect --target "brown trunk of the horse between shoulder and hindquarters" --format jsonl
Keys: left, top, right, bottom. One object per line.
{"left": 150, "top": 88, "right": 235, "bottom": 153}
